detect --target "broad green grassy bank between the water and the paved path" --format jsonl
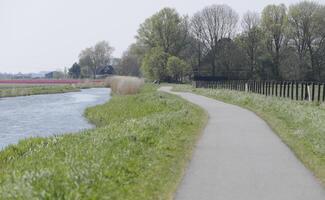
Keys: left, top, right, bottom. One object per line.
{"left": 0, "top": 85, "right": 206, "bottom": 200}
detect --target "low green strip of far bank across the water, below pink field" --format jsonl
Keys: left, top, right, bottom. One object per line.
{"left": 0, "top": 85, "right": 79, "bottom": 97}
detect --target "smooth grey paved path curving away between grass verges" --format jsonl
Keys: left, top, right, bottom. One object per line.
{"left": 160, "top": 87, "right": 325, "bottom": 200}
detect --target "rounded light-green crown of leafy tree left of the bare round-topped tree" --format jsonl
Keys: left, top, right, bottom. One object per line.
{"left": 136, "top": 8, "right": 188, "bottom": 56}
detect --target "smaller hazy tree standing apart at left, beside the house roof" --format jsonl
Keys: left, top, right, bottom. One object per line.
{"left": 79, "top": 41, "right": 114, "bottom": 79}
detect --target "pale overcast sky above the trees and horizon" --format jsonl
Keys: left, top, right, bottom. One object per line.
{"left": 0, "top": 0, "right": 325, "bottom": 73}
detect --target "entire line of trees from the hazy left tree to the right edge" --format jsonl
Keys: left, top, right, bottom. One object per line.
{"left": 69, "top": 1, "right": 325, "bottom": 82}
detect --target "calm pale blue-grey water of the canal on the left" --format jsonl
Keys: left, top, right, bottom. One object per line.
{"left": 0, "top": 88, "right": 110, "bottom": 149}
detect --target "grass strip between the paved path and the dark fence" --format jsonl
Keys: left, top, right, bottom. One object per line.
{"left": 174, "top": 85, "right": 325, "bottom": 186}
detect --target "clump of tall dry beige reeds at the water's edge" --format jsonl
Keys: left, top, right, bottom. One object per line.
{"left": 106, "top": 76, "right": 144, "bottom": 95}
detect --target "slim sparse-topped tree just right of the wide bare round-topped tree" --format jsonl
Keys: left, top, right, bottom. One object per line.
{"left": 237, "top": 11, "right": 262, "bottom": 79}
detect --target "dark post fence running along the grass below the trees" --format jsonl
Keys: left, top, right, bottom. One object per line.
{"left": 195, "top": 80, "right": 325, "bottom": 102}
